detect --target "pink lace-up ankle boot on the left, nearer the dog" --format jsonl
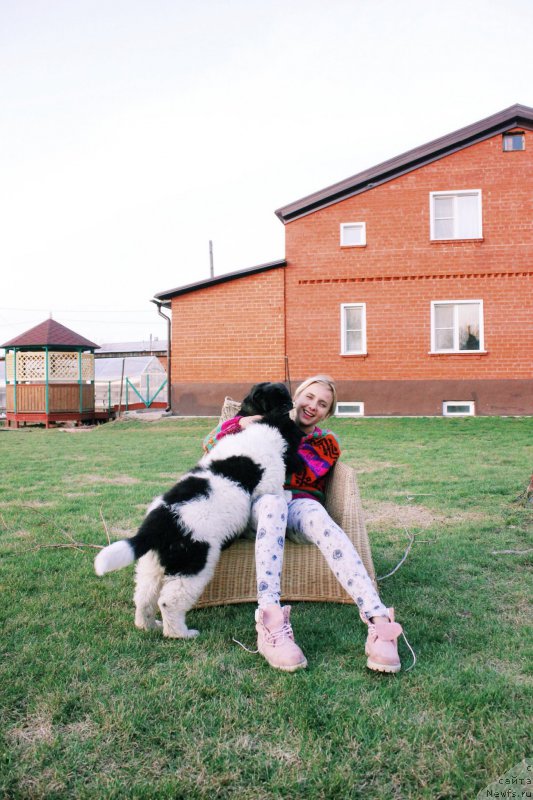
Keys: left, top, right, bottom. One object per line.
{"left": 255, "top": 605, "right": 307, "bottom": 672}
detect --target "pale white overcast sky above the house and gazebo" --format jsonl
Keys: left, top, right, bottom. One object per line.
{"left": 0, "top": 0, "right": 533, "bottom": 344}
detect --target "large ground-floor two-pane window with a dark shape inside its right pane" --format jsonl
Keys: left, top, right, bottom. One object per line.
{"left": 431, "top": 300, "right": 484, "bottom": 353}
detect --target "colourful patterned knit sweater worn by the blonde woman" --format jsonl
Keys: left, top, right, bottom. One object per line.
{"left": 203, "top": 416, "right": 341, "bottom": 504}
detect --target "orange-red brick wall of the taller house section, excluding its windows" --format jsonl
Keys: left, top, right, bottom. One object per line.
{"left": 286, "top": 132, "right": 533, "bottom": 388}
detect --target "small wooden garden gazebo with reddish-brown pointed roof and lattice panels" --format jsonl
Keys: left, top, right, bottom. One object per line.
{"left": 2, "top": 319, "right": 98, "bottom": 428}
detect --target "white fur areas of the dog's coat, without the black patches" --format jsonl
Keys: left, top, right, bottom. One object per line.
{"left": 95, "top": 424, "right": 287, "bottom": 638}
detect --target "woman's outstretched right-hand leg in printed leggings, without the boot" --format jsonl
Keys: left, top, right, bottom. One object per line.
{"left": 288, "top": 499, "right": 388, "bottom": 620}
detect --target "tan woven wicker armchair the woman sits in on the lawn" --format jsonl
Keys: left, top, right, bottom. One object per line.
{"left": 196, "top": 397, "right": 376, "bottom": 608}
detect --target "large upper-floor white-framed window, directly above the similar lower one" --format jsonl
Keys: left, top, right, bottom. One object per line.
{"left": 429, "top": 189, "right": 482, "bottom": 241}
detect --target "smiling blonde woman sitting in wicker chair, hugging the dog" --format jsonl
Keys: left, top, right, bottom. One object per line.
{"left": 204, "top": 375, "right": 402, "bottom": 672}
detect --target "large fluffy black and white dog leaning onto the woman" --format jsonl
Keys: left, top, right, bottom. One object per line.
{"left": 94, "top": 384, "right": 303, "bottom": 638}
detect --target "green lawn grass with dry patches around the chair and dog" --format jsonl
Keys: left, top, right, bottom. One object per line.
{"left": 0, "top": 418, "right": 533, "bottom": 800}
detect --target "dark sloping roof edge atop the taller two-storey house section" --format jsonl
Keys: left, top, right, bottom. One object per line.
{"left": 275, "top": 104, "right": 533, "bottom": 224}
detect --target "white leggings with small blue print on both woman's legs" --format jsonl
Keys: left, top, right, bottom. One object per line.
{"left": 251, "top": 495, "right": 388, "bottom": 619}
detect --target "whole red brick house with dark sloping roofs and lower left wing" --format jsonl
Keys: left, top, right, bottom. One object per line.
{"left": 155, "top": 105, "right": 533, "bottom": 415}
